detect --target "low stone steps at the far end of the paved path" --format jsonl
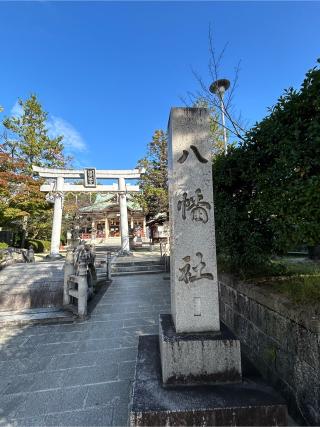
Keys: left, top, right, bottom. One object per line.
{"left": 111, "top": 257, "right": 165, "bottom": 277}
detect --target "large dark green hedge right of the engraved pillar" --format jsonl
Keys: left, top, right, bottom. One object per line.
{"left": 213, "top": 59, "right": 320, "bottom": 271}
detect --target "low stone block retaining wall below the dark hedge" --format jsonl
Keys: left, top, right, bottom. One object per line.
{"left": 219, "top": 275, "right": 320, "bottom": 425}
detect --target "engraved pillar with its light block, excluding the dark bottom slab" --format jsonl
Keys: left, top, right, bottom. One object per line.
{"left": 160, "top": 108, "right": 241, "bottom": 383}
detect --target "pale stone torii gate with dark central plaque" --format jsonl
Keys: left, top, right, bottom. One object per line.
{"left": 32, "top": 166, "right": 144, "bottom": 257}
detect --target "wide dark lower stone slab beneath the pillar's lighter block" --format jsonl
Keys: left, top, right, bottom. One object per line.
{"left": 130, "top": 335, "right": 287, "bottom": 426}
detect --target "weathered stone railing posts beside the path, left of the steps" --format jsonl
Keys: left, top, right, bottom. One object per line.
{"left": 63, "top": 243, "right": 97, "bottom": 317}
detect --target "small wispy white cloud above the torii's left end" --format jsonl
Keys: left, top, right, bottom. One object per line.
{"left": 47, "top": 116, "right": 87, "bottom": 153}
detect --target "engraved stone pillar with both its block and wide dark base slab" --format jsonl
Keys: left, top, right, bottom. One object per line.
{"left": 130, "top": 108, "right": 287, "bottom": 426}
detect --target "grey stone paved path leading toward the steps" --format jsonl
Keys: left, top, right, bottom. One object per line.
{"left": 0, "top": 274, "right": 170, "bottom": 426}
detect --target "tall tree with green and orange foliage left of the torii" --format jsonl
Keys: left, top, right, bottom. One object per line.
{"left": 0, "top": 95, "right": 67, "bottom": 246}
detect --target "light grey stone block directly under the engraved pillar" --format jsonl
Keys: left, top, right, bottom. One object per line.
{"left": 159, "top": 314, "right": 242, "bottom": 385}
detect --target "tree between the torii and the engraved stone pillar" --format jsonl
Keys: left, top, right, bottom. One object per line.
{"left": 136, "top": 130, "right": 168, "bottom": 217}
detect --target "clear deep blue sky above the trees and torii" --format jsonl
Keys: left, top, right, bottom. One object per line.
{"left": 0, "top": 1, "right": 320, "bottom": 169}
